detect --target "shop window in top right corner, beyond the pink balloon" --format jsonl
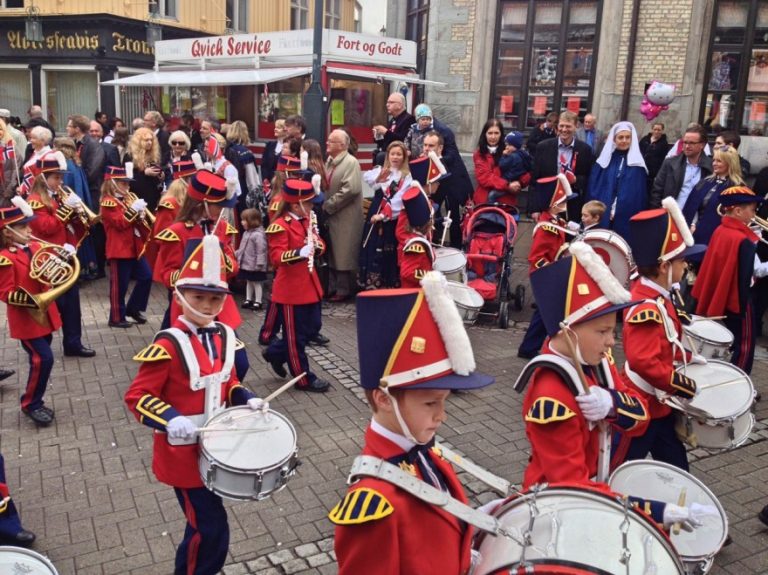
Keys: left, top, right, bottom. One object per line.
{"left": 701, "top": 0, "right": 768, "bottom": 136}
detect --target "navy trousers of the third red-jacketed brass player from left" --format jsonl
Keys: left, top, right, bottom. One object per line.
{"left": 109, "top": 257, "right": 152, "bottom": 322}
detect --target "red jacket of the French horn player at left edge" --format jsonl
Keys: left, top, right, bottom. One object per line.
{"left": 0, "top": 242, "right": 61, "bottom": 339}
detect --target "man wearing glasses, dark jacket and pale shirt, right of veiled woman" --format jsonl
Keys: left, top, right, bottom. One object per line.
{"left": 650, "top": 124, "right": 712, "bottom": 209}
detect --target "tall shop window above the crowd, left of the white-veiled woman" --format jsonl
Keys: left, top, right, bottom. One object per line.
{"left": 491, "top": 0, "right": 602, "bottom": 129}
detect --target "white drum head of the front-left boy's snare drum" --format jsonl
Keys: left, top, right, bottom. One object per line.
{"left": 200, "top": 407, "right": 296, "bottom": 470}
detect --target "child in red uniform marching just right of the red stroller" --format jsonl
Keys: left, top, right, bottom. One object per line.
{"left": 517, "top": 174, "right": 576, "bottom": 359}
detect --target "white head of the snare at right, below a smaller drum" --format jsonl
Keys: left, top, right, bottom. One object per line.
{"left": 678, "top": 359, "right": 755, "bottom": 419}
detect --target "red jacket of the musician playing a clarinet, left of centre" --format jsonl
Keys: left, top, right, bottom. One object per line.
{"left": 266, "top": 209, "right": 325, "bottom": 305}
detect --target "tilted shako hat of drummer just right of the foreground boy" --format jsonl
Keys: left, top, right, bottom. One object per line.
{"left": 531, "top": 242, "right": 633, "bottom": 336}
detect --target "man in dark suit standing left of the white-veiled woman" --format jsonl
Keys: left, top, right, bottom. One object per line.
{"left": 528, "top": 111, "right": 595, "bottom": 220}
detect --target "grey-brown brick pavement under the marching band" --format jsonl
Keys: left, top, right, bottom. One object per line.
{"left": 0, "top": 223, "right": 768, "bottom": 575}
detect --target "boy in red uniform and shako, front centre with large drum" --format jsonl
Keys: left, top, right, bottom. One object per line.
{"left": 329, "top": 272, "right": 493, "bottom": 575}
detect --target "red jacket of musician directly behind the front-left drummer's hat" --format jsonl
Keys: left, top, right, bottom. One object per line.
{"left": 152, "top": 220, "right": 243, "bottom": 329}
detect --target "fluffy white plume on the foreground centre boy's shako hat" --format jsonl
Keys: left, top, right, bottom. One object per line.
{"left": 421, "top": 271, "right": 476, "bottom": 375}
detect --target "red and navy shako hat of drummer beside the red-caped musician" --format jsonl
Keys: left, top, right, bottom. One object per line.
{"left": 628, "top": 197, "right": 707, "bottom": 266}
